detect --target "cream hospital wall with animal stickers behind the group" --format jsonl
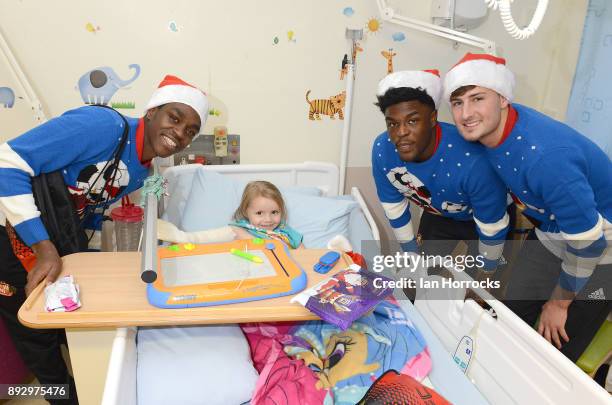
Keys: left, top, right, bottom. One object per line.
{"left": 0, "top": 0, "right": 588, "bottom": 251}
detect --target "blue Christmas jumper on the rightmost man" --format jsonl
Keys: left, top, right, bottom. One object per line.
{"left": 487, "top": 104, "right": 612, "bottom": 292}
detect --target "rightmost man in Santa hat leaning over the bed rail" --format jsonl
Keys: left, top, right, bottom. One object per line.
{"left": 444, "top": 53, "right": 612, "bottom": 361}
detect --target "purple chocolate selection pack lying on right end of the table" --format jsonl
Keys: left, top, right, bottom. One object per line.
{"left": 291, "top": 264, "right": 393, "bottom": 330}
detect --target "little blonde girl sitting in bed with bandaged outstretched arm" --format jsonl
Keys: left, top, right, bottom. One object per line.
{"left": 157, "top": 181, "right": 303, "bottom": 249}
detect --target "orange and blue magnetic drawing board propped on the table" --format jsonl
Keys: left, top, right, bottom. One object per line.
{"left": 147, "top": 239, "right": 306, "bottom": 308}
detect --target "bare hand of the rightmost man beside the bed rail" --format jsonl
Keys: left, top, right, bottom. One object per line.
{"left": 538, "top": 285, "right": 574, "bottom": 349}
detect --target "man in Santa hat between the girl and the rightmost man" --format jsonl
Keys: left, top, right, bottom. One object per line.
{"left": 372, "top": 70, "right": 510, "bottom": 280}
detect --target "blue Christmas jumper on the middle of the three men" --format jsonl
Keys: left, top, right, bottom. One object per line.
{"left": 372, "top": 122, "right": 509, "bottom": 269}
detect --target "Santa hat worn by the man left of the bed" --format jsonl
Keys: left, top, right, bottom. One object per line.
{"left": 145, "top": 75, "right": 208, "bottom": 130}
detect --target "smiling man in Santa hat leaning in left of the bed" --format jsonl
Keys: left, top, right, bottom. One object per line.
{"left": 0, "top": 76, "right": 208, "bottom": 404}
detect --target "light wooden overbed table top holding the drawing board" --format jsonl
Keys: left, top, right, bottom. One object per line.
{"left": 19, "top": 249, "right": 350, "bottom": 329}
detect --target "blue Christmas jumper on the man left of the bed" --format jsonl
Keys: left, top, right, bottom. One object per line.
{"left": 0, "top": 106, "right": 148, "bottom": 246}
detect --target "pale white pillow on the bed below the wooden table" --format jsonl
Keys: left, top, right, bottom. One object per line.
{"left": 136, "top": 325, "right": 258, "bottom": 405}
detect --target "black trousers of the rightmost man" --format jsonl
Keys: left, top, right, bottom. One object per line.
{"left": 503, "top": 230, "right": 612, "bottom": 362}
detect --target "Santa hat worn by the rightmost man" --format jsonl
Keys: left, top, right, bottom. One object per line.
{"left": 444, "top": 52, "right": 514, "bottom": 101}
